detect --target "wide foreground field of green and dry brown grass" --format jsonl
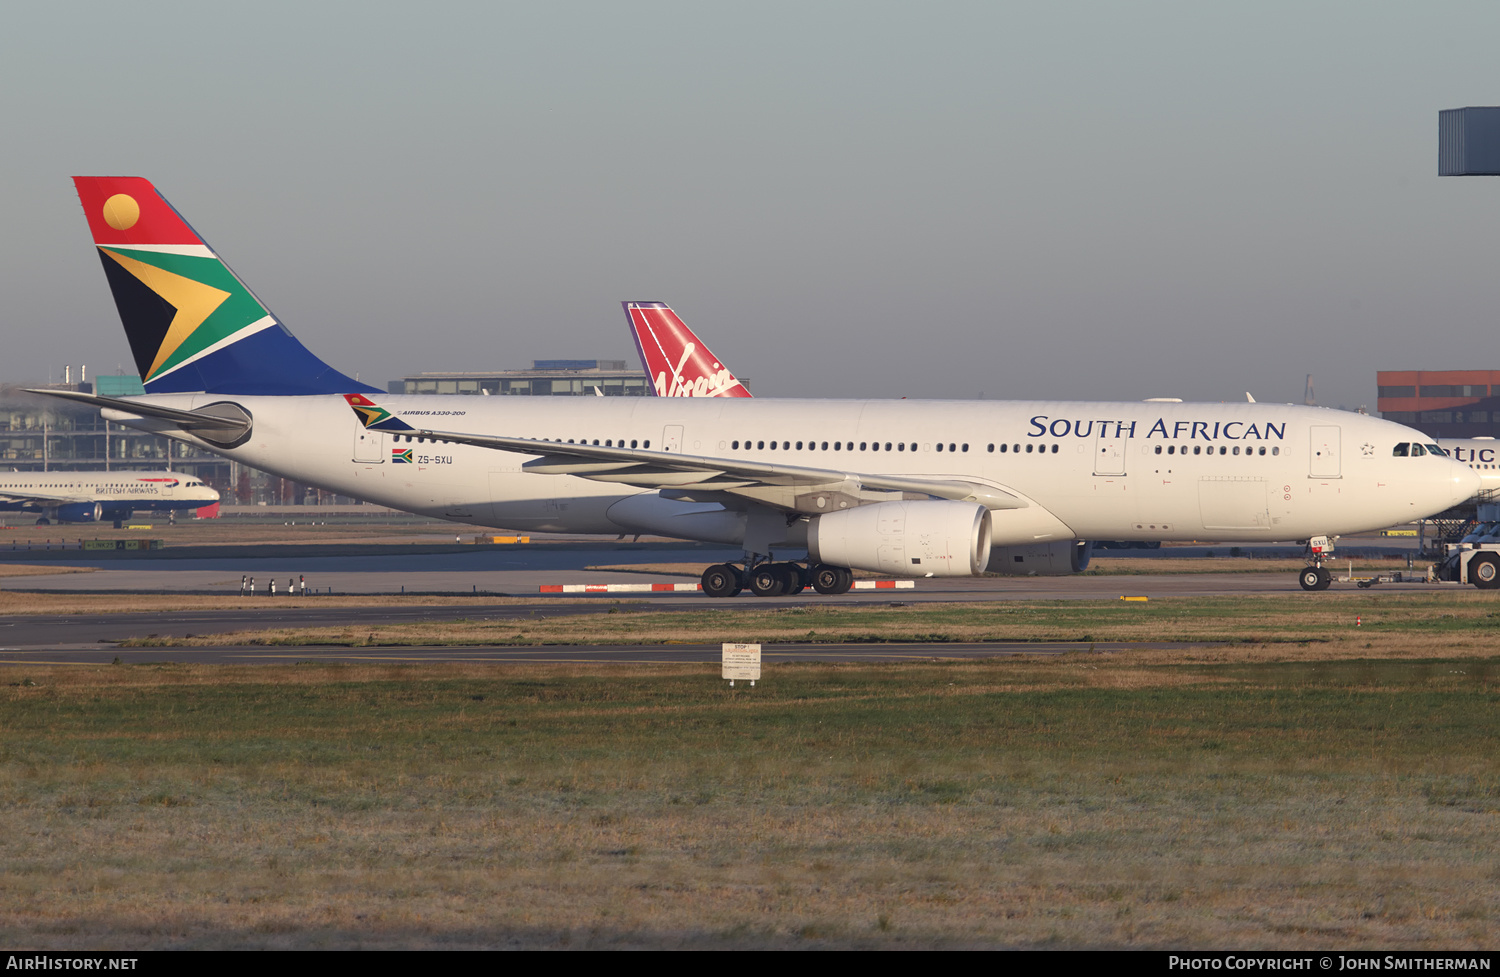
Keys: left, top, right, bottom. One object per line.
{"left": 0, "top": 654, "right": 1500, "bottom": 948}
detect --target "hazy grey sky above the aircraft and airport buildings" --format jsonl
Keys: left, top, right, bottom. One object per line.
{"left": 0, "top": 0, "right": 1500, "bottom": 408}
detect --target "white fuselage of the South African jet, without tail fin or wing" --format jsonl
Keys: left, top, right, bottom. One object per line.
{"left": 114, "top": 393, "right": 1479, "bottom": 545}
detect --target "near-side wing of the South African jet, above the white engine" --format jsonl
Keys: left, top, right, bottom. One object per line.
{"left": 405, "top": 429, "right": 1029, "bottom": 513}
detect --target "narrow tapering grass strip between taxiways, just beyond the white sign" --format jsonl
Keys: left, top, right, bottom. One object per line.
{"left": 120, "top": 591, "right": 1500, "bottom": 656}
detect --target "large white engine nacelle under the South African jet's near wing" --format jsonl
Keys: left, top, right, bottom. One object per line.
{"left": 807, "top": 501, "right": 990, "bottom": 576}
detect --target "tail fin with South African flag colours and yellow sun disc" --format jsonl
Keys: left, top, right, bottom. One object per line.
{"left": 74, "top": 177, "right": 378, "bottom": 395}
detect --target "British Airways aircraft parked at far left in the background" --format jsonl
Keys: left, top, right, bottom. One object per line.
{"left": 0, "top": 471, "right": 219, "bottom": 528}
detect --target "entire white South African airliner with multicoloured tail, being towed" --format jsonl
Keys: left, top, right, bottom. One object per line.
{"left": 38, "top": 177, "right": 1479, "bottom": 596}
